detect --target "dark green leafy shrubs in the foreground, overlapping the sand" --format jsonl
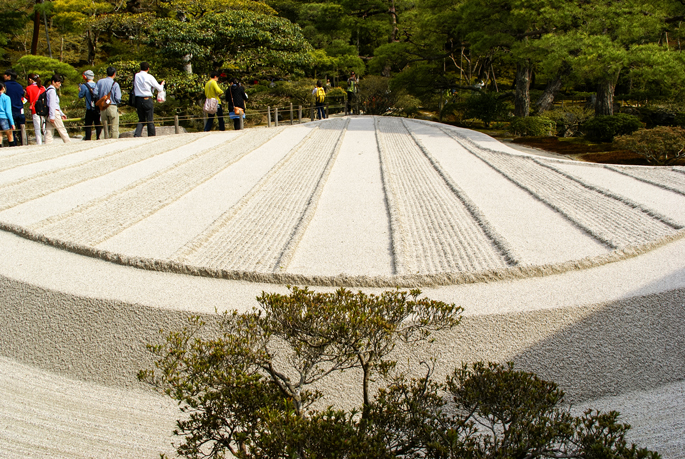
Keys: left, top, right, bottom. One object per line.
{"left": 139, "top": 287, "right": 659, "bottom": 459}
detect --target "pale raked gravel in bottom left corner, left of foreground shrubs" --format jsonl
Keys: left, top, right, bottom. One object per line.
{"left": 0, "top": 357, "right": 178, "bottom": 459}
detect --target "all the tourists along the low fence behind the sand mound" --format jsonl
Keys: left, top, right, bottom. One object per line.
{"left": 0, "top": 62, "right": 359, "bottom": 146}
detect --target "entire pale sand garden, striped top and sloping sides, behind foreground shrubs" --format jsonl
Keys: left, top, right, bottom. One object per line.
{"left": 0, "top": 117, "right": 685, "bottom": 458}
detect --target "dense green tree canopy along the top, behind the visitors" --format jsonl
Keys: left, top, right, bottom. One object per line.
{"left": 0, "top": 0, "right": 685, "bottom": 117}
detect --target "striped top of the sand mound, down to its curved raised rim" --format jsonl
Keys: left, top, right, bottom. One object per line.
{"left": 0, "top": 118, "right": 685, "bottom": 287}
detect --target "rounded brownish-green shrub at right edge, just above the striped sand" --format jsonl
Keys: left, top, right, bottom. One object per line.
{"left": 616, "top": 126, "right": 685, "bottom": 166}
